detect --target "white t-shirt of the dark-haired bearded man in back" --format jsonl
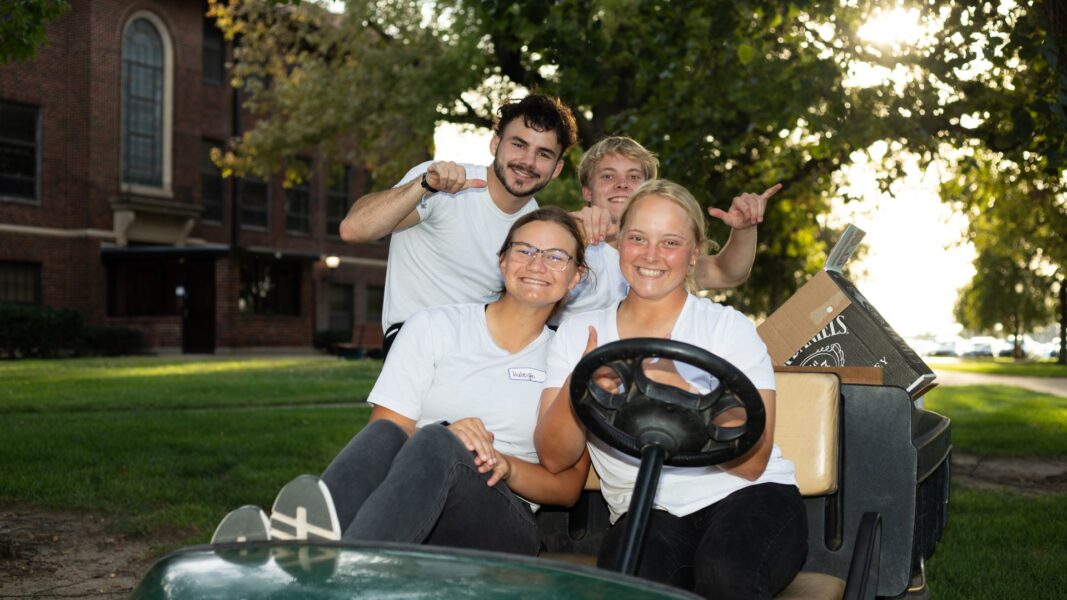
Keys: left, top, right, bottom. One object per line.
{"left": 382, "top": 161, "right": 538, "bottom": 329}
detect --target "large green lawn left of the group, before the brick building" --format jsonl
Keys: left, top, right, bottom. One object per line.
{"left": 0, "top": 358, "right": 381, "bottom": 546}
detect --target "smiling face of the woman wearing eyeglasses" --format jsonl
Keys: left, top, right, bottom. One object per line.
{"left": 500, "top": 216, "right": 580, "bottom": 305}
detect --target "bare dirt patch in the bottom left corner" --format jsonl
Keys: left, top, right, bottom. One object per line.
{"left": 0, "top": 506, "right": 164, "bottom": 598}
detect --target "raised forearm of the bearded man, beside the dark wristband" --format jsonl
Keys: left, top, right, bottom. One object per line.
{"left": 340, "top": 179, "right": 426, "bottom": 243}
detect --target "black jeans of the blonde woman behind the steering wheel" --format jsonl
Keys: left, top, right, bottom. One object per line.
{"left": 596, "top": 484, "right": 808, "bottom": 598}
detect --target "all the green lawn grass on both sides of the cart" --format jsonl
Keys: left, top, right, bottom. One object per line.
{"left": 0, "top": 358, "right": 1067, "bottom": 599}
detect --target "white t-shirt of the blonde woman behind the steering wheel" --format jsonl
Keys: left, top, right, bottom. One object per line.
{"left": 544, "top": 295, "right": 796, "bottom": 522}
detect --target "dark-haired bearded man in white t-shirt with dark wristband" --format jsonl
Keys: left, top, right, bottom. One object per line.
{"left": 340, "top": 94, "right": 584, "bottom": 352}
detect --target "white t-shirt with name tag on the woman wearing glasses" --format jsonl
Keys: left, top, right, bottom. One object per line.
{"left": 367, "top": 304, "right": 552, "bottom": 462}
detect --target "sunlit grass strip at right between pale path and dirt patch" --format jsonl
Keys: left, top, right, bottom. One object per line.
{"left": 926, "top": 385, "right": 1067, "bottom": 458}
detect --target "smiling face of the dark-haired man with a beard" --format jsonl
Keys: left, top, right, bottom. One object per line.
{"left": 489, "top": 119, "right": 563, "bottom": 198}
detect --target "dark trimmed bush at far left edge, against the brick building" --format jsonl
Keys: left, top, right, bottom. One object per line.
{"left": 0, "top": 303, "right": 82, "bottom": 359}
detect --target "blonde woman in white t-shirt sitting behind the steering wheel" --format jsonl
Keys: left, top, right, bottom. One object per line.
{"left": 535, "top": 179, "right": 808, "bottom": 598}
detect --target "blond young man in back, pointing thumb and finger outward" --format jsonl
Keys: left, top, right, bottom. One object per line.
{"left": 554, "top": 136, "right": 782, "bottom": 322}
